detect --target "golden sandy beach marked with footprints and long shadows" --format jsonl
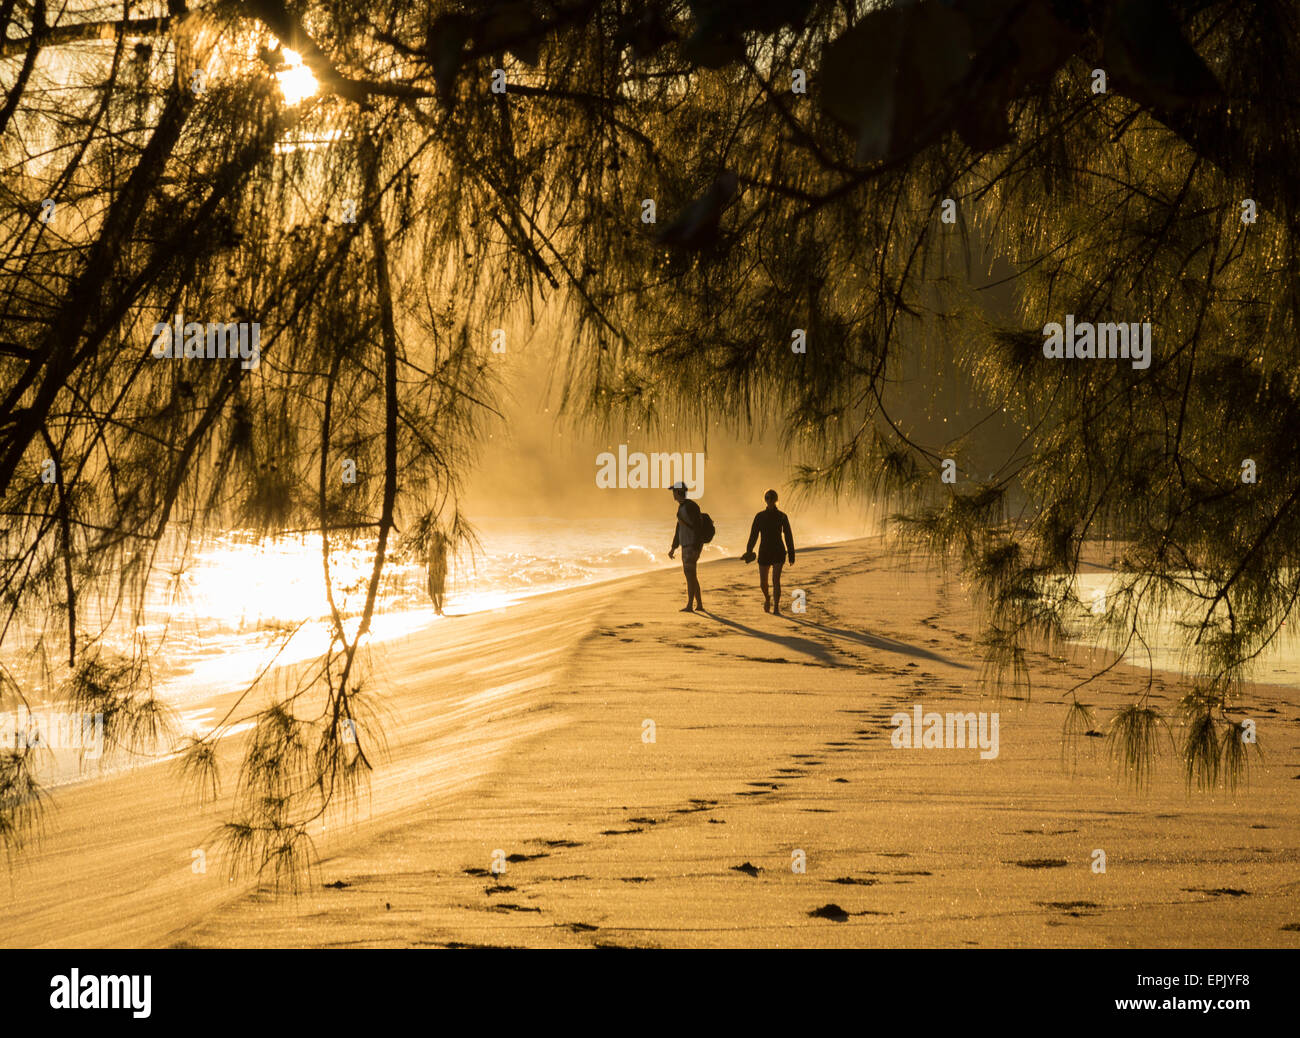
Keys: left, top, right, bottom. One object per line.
{"left": 0, "top": 539, "right": 1300, "bottom": 947}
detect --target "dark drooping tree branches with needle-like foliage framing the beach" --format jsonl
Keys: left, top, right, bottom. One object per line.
{"left": 0, "top": 0, "right": 1300, "bottom": 872}
